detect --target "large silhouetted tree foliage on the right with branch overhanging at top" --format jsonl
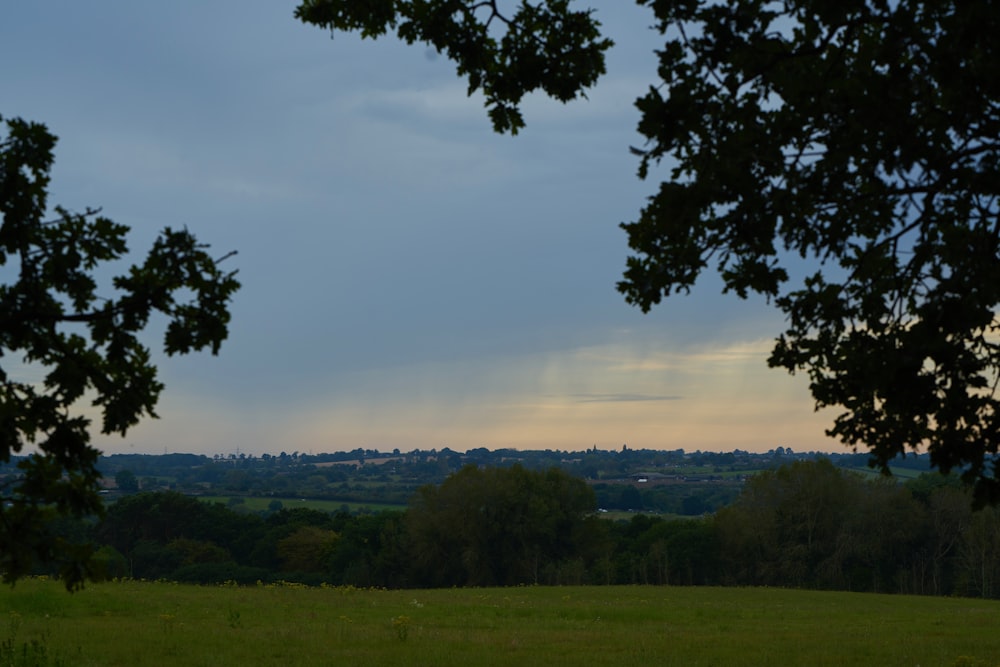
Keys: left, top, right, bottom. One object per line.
{"left": 297, "top": 0, "right": 1000, "bottom": 504}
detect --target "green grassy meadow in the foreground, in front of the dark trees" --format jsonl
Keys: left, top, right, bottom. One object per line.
{"left": 0, "top": 580, "right": 1000, "bottom": 667}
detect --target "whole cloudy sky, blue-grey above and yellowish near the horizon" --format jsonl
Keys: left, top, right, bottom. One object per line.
{"left": 0, "top": 0, "right": 842, "bottom": 455}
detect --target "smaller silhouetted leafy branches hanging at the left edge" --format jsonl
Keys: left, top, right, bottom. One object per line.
{"left": 0, "top": 118, "right": 239, "bottom": 588}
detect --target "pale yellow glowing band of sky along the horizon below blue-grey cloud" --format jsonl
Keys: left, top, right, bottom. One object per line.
{"left": 95, "top": 332, "right": 843, "bottom": 453}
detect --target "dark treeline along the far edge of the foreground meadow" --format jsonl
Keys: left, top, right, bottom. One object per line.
{"left": 52, "top": 459, "right": 1000, "bottom": 597}
